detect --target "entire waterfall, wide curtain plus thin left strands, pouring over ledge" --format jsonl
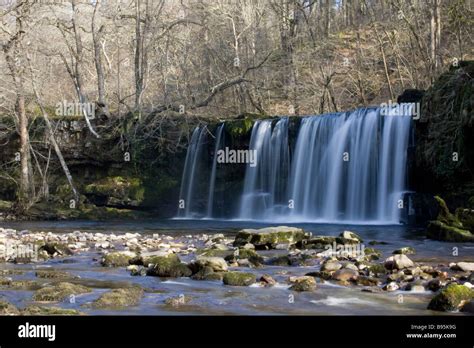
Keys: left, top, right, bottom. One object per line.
{"left": 179, "top": 104, "right": 412, "bottom": 224}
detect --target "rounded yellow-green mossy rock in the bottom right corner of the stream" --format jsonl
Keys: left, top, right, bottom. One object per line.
{"left": 428, "top": 284, "right": 474, "bottom": 312}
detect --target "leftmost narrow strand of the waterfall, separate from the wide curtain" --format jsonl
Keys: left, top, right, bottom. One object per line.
{"left": 178, "top": 126, "right": 207, "bottom": 218}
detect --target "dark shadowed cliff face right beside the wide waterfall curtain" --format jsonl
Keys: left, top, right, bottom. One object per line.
{"left": 410, "top": 61, "right": 474, "bottom": 209}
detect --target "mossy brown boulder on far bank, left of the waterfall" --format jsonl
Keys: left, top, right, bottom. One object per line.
{"left": 84, "top": 176, "right": 145, "bottom": 207}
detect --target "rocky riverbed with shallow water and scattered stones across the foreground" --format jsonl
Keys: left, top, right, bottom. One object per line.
{"left": 0, "top": 226, "right": 474, "bottom": 315}
